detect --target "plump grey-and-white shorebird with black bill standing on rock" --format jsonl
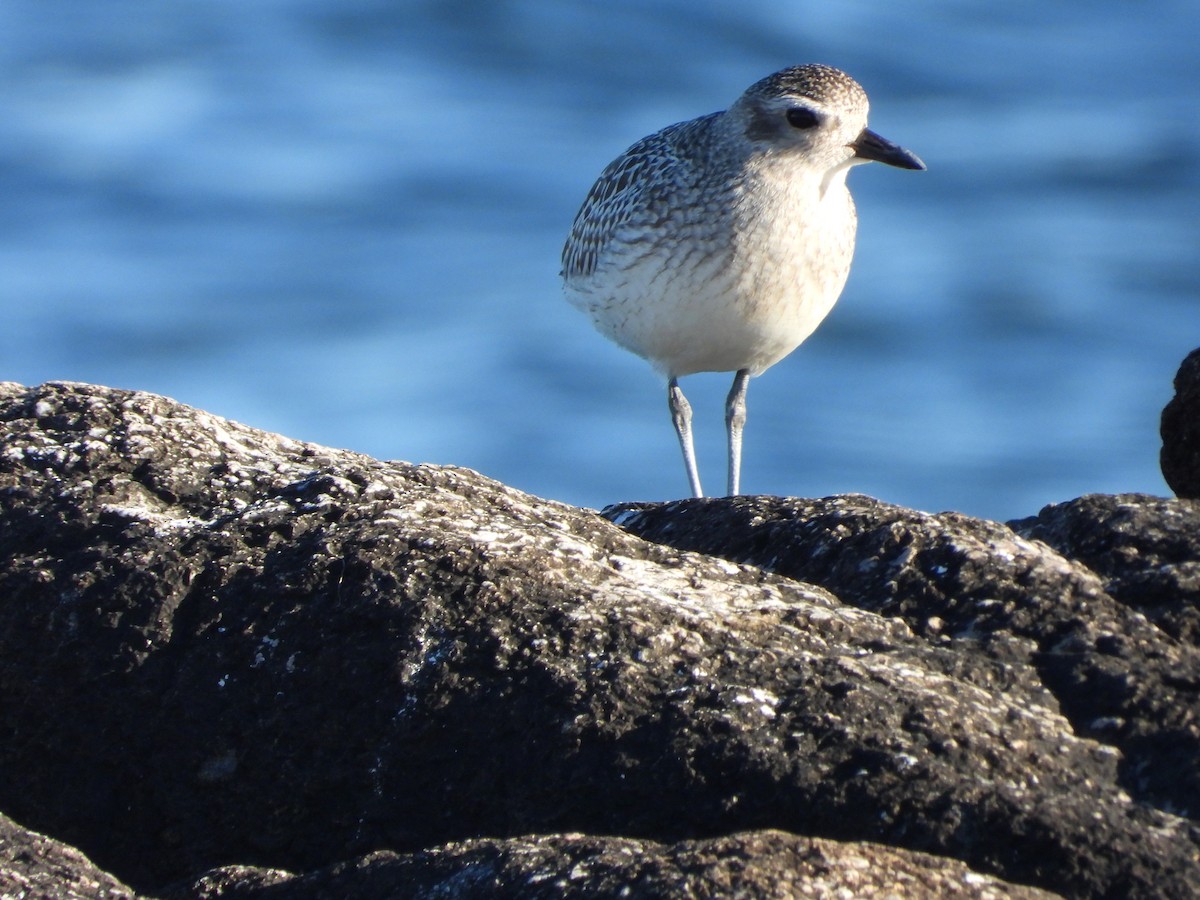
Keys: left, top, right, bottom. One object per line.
{"left": 562, "top": 64, "right": 925, "bottom": 497}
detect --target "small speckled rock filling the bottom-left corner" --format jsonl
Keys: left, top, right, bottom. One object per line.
{"left": 0, "top": 815, "right": 134, "bottom": 900}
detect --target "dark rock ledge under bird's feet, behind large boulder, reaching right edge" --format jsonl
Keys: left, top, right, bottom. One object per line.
{"left": 606, "top": 494, "right": 1200, "bottom": 818}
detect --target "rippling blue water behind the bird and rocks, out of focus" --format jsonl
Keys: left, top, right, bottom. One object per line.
{"left": 0, "top": 0, "right": 1200, "bottom": 518}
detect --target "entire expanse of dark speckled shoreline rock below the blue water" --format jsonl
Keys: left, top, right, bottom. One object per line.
{"left": 0, "top": 384, "right": 1200, "bottom": 898}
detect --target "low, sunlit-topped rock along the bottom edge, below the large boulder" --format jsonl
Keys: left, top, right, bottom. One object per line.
{"left": 166, "top": 832, "right": 1057, "bottom": 900}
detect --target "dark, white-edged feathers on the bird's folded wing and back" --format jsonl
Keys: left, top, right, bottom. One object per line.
{"left": 563, "top": 113, "right": 721, "bottom": 278}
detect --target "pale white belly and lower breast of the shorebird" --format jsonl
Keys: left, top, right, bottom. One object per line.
{"left": 566, "top": 184, "right": 856, "bottom": 376}
